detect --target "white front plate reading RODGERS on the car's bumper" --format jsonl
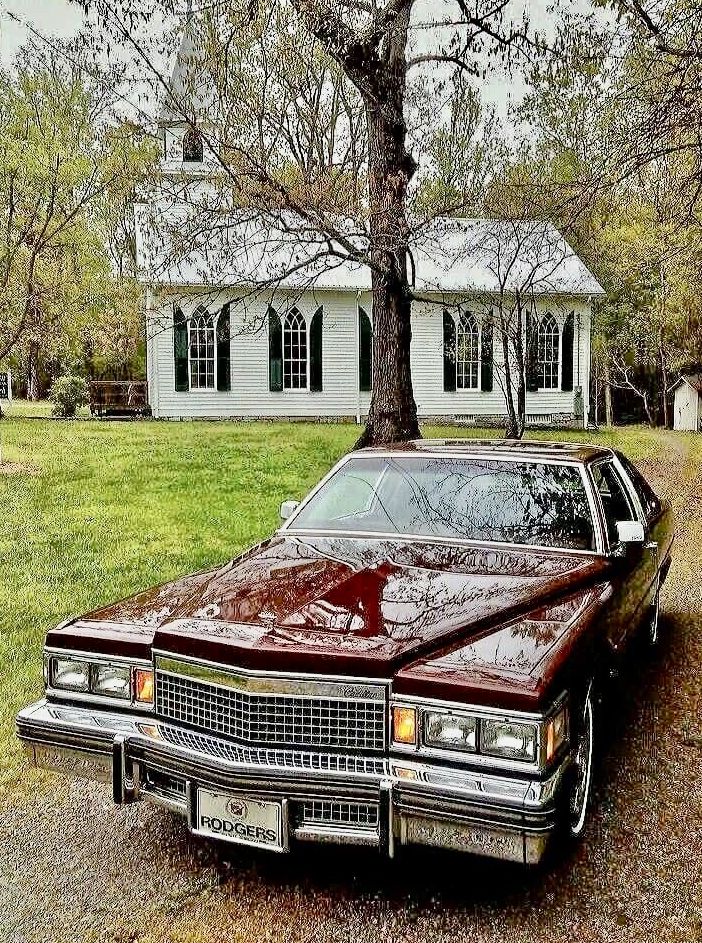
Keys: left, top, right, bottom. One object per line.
{"left": 193, "top": 789, "right": 283, "bottom": 851}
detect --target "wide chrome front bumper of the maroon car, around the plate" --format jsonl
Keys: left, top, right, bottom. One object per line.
{"left": 17, "top": 700, "right": 567, "bottom": 864}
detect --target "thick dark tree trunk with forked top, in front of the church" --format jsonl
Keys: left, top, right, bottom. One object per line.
{"left": 292, "top": 0, "right": 420, "bottom": 448}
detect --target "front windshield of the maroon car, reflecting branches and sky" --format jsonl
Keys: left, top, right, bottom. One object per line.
{"left": 291, "top": 455, "right": 593, "bottom": 550}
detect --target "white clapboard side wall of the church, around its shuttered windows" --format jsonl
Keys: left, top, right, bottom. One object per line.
{"left": 147, "top": 291, "right": 590, "bottom": 418}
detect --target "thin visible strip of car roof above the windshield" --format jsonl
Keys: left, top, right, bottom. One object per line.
{"left": 356, "top": 439, "right": 613, "bottom": 463}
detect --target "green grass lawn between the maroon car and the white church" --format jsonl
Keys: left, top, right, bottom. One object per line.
{"left": 0, "top": 416, "right": 672, "bottom": 801}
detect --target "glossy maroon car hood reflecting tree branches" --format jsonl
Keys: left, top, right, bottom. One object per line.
{"left": 49, "top": 534, "right": 606, "bottom": 677}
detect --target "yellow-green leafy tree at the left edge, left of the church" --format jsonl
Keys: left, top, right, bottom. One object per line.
{"left": 0, "top": 43, "right": 154, "bottom": 398}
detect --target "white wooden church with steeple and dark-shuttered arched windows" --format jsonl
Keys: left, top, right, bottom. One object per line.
{"left": 136, "top": 16, "right": 602, "bottom": 424}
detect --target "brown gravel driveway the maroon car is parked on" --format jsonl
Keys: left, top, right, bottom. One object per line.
{"left": 0, "top": 436, "right": 702, "bottom": 943}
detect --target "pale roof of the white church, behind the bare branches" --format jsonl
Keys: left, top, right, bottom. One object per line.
{"left": 137, "top": 203, "right": 603, "bottom": 296}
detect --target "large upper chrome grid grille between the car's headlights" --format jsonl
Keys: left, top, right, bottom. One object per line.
{"left": 156, "top": 671, "right": 386, "bottom": 751}
